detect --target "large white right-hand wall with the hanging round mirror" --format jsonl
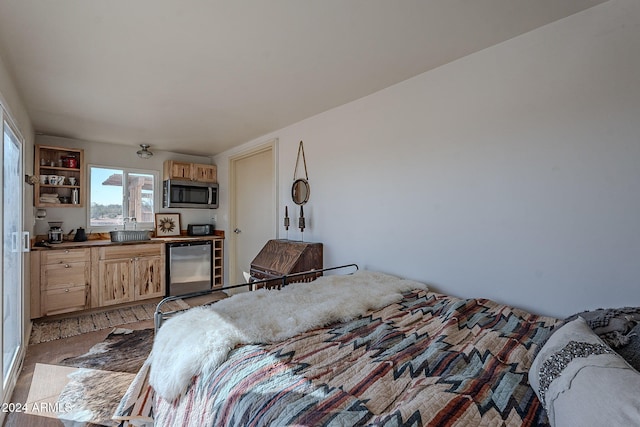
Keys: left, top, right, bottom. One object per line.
{"left": 214, "top": 0, "right": 640, "bottom": 317}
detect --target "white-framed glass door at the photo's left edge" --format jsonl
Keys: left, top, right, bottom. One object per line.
{"left": 0, "top": 108, "right": 29, "bottom": 402}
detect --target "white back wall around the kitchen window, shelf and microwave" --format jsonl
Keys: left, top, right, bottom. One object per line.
{"left": 29, "top": 135, "right": 216, "bottom": 235}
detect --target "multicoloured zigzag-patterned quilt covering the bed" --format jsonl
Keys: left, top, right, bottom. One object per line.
{"left": 117, "top": 291, "right": 558, "bottom": 427}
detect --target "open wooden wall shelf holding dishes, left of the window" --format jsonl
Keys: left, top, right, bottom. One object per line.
{"left": 33, "top": 145, "right": 86, "bottom": 208}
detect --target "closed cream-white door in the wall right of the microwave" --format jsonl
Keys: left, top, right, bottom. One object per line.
{"left": 229, "top": 141, "right": 277, "bottom": 284}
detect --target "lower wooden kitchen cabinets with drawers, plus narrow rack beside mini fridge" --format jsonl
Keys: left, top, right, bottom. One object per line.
{"left": 30, "top": 238, "right": 224, "bottom": 319}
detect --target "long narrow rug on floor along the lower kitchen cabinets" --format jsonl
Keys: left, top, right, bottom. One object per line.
{"left": 29, "top": 300, "right": 190, "bottom": 344}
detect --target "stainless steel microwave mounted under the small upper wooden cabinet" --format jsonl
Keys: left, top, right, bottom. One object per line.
{"left": 162, "top": 179, "right": 218, "bottom": 209}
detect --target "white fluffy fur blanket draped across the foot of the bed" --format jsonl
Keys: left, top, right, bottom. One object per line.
{"left": 149, "top": 271, "right": 427, "bottom": 401}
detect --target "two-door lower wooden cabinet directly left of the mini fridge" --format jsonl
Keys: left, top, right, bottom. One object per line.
{"left": 91, "top": 243, "right": 165, "bottom": 307}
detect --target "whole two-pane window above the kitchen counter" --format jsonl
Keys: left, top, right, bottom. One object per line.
{"left": 87, "top": 165, "right": 158, "bottom": 230}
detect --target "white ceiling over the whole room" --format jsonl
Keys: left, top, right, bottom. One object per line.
{"left": 0, "top": 0, "right": 604, "bottom": 155}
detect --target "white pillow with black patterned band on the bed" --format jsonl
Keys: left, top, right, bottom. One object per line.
{"left": 529, "top": 317, "right": 640, "bottom": 427}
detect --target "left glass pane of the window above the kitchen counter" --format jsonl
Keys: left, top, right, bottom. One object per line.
{"left": 89, "top": 166, "right": 124, "bottom": 227}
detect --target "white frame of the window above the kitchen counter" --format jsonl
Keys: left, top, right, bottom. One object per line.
{"left": 87, "top": 163, "right": 162, "bottom": 232}
